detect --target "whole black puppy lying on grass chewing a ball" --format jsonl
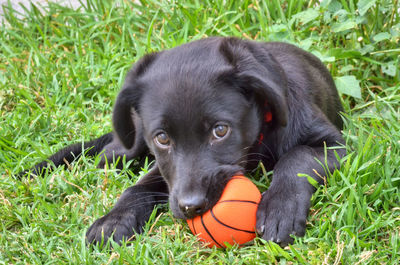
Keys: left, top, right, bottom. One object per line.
{"left": 25, "top": 37, "right": 345, "bottom": 244}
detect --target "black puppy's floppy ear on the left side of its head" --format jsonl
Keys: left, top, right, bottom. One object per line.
{"left": 113, "top": 53, "right": 157, "bottom": 149}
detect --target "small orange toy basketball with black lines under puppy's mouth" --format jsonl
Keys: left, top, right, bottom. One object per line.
{"left": 187, "top": 175, "right": 261, "bottom": 248}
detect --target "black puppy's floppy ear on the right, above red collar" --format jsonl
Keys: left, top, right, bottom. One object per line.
{"left": 219, "top": 38, "right": 288, "bottom": 126}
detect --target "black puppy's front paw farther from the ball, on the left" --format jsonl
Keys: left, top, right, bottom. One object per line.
{"left": 86, "top": 208, "right": 149, "bottom": 244}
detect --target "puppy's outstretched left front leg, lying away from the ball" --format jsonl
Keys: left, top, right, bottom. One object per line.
{"left": 86, "top": 167, "right": 168, "bottom": 244}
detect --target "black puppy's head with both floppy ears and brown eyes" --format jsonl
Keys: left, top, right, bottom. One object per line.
{"left": 113, "top": 38, "right": 287, "bottom": 218}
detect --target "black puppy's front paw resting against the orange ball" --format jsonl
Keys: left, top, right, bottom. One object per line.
{"left": 256, "top": 186, "right": 311, "bottom": 246}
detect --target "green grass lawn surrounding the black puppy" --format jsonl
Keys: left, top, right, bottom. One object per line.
{"left": 0, "top": 0, "right": 400, "bottom": 264}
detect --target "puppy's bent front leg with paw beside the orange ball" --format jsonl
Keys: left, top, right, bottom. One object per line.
{"left": 256, "top": 128, "right": 345, "bottom": 245}
